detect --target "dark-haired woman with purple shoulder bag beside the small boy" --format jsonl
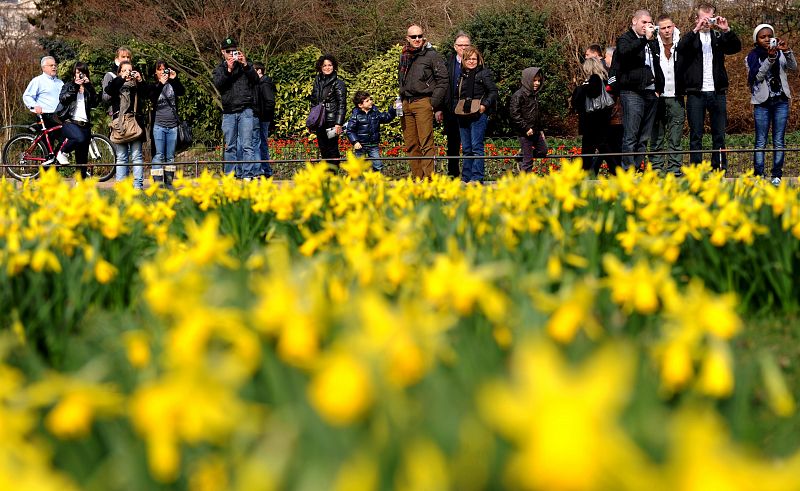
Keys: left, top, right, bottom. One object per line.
{"left": 311, "top": 54, "right": 347, "bottom": 167}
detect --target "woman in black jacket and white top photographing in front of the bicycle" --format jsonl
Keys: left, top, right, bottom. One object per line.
{"left": 56, "top": 61, "right": 100, "bottom": 178}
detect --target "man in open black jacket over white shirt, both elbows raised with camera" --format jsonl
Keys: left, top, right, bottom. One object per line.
{"left": 675, "top": 3, "right": 742, "bottom": 170}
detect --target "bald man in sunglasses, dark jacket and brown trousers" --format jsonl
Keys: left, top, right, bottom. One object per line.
{"left": 397, "top": 24, "right": 447, "bottom": 179}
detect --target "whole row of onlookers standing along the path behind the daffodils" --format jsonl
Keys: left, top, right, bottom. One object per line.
{"left": 23, "top": 3, "right": 797, "bottom": 187}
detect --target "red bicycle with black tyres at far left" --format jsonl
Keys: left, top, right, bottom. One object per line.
{"left": 3, "top": 115, "right": 116, "bottom": 182}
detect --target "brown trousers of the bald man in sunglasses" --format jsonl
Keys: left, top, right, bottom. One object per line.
{"left": 400, "top": 97, "right": 434, "bottom": 179}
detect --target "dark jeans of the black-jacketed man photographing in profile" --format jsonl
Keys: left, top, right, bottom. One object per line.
{"left": 620, "top": 90, "right": 658, "bottom": 170}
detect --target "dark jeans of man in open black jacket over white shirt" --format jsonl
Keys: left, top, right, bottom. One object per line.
{"left": 686, "top": 92, "right": 728, "bottom": 169}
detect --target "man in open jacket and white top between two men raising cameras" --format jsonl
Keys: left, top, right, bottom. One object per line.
{"left": 650, "top": 14, "right": 686, "bottom": 176}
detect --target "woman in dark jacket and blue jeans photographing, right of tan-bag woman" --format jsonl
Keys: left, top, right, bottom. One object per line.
{"left": 150, "top": 60, "right": 186, "bottom": 189}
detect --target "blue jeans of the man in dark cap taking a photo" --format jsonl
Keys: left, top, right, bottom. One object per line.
{"left": 222, "top": 108, "right": 261, "bottom": 179}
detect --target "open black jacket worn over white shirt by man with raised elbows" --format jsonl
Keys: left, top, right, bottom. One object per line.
{"left": 675, "top": 31, "right": 742, "bottom": 92}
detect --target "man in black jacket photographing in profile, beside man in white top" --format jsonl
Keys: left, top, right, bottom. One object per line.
{"left": 616, "top": 10, "right": 664, "bottom": 169}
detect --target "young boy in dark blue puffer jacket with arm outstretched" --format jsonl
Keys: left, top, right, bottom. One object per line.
{"left": 347, "top": 90, "right": 397, "bottom": 172}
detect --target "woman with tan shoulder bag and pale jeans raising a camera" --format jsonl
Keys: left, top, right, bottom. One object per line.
{"left": 105, "top": 61, "right": 149, "bottom": 189}
